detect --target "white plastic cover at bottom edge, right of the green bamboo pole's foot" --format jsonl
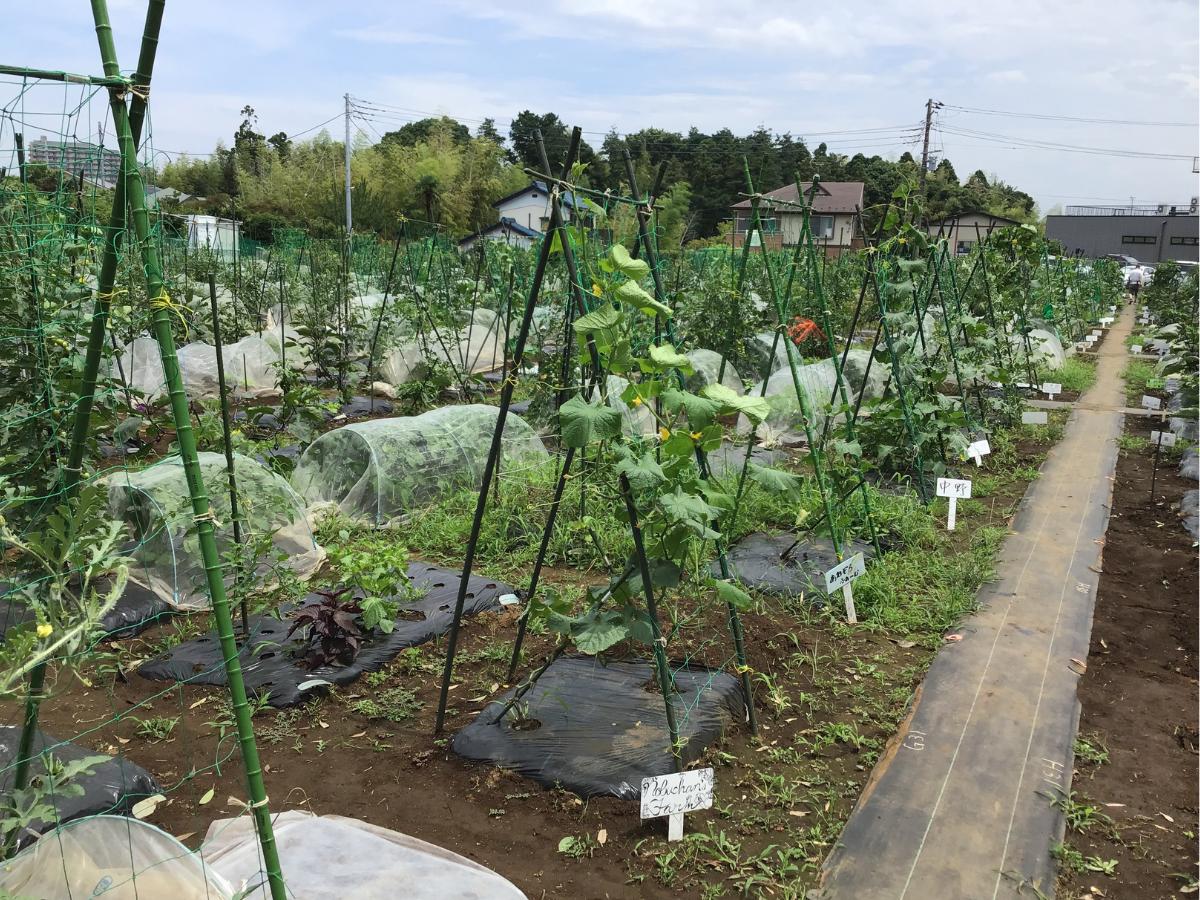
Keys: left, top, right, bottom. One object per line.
{"left": 202, "top": 810, "right": 524, "bottom": 900}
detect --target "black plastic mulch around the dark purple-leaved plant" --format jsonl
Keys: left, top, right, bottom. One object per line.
{"left": 139, "top": 563, "right": 514, "bottom": 707}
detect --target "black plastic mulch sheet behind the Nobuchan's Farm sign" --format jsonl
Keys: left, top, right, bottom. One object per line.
{"left": 451, "top": 655, "right": 745, "bottom": 800}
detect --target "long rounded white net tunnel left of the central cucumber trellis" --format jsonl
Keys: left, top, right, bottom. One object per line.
{"left": 292, "top": 404, "right": 548, "bottom": 524}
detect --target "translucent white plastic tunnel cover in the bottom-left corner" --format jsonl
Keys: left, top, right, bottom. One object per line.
{"left": 0, "top": 816, "right": 234, "bottom": 900}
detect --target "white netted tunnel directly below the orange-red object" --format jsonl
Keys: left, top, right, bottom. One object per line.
{"left": 738, "top": 350, "right": 887, "bottom": 437}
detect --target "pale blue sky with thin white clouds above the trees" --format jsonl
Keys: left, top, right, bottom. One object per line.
{"left": 0, "top": 0, "right": 1200, "bottom": 211}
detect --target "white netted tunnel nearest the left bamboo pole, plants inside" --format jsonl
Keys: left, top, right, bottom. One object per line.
{"left": 104, "top": 452, "right": 324, "bottom": 610}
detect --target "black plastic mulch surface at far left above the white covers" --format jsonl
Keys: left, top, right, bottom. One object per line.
{"left": 0, "top": 725, "right": 161, "bottom": 846}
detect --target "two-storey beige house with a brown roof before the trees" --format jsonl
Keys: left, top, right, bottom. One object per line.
{"left": 731, "top": 181, "right": 864, "bottom": 257}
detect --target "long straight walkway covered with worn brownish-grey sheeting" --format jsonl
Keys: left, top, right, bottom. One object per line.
{"left": 822, "top": 317, "right": 1132, "bottom": 900}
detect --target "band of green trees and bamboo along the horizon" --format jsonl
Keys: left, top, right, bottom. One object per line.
{"left": 157, "top": 106, "right": 1037, "bottom": 246}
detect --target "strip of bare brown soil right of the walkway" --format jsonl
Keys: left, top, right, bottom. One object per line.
{"left": 1060, "top": 416, "right": 1200, "bottom": 900}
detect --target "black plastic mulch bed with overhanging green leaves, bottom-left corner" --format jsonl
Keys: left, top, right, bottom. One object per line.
{"left": 0, "top": 725, "right": 160, "bottom": 846}
